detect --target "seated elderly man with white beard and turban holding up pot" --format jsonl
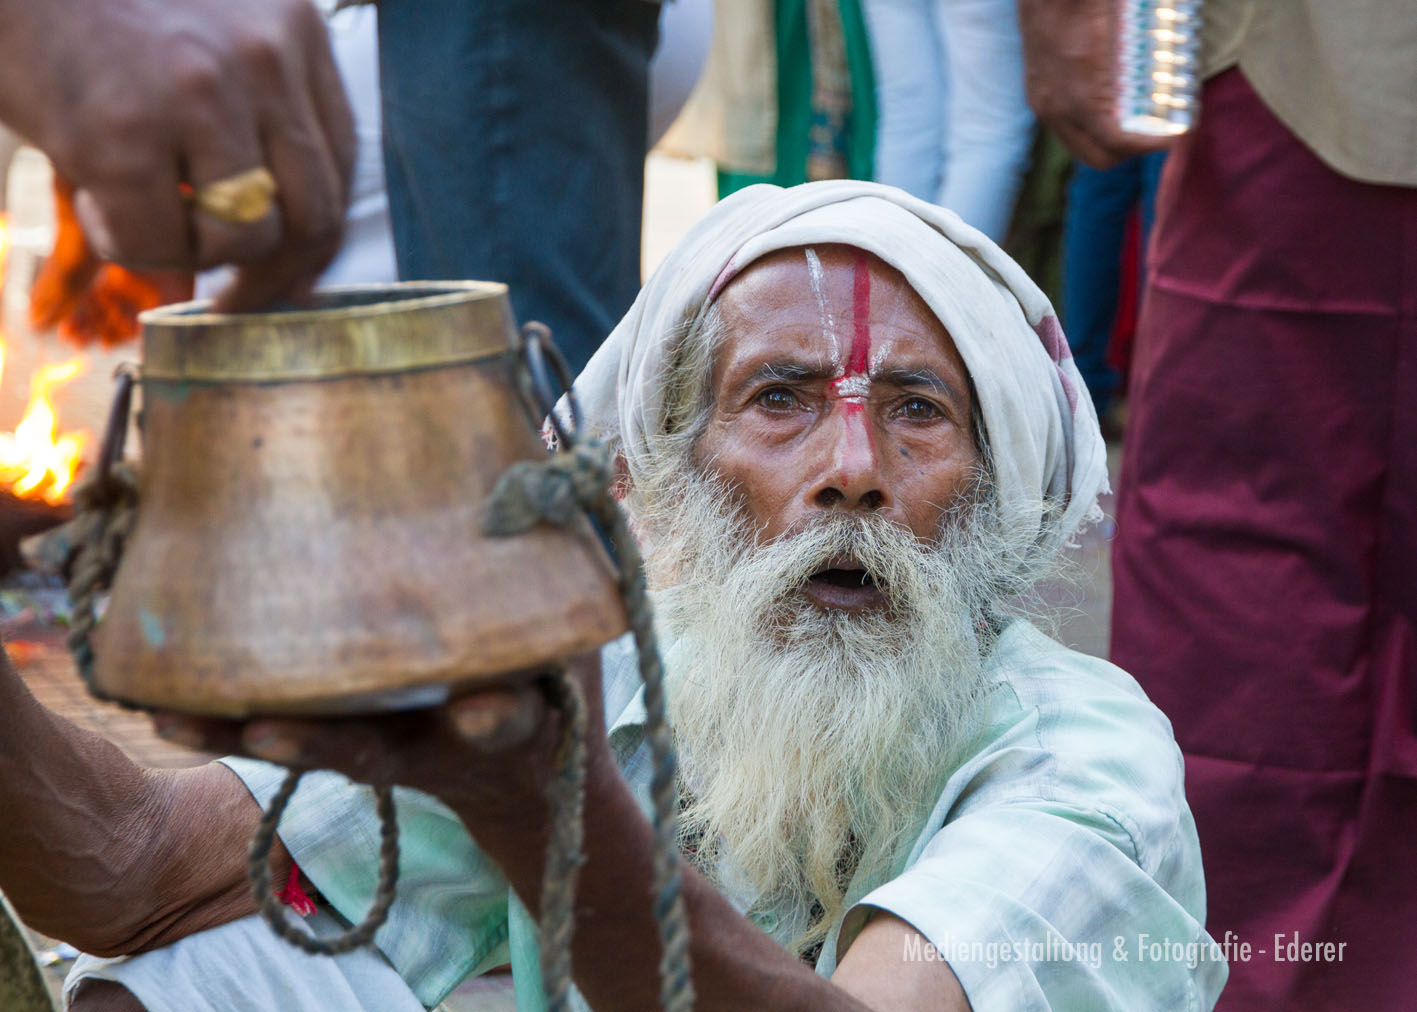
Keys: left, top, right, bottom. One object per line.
{"left": 19, "top": 181, "right": 1226, "bottom": 1012}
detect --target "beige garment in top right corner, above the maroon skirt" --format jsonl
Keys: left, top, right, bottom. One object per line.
{"left": 1202, "top": 0, "right": 1417, "bottom": 186}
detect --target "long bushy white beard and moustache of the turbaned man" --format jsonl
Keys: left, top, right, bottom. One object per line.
{"left": 631, "top": 471, "right": 1017, "bottom": 951}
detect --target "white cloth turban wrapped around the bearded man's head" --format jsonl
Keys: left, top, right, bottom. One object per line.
{"left": 575, "top": 180, "right": 1107, "bottom": 546}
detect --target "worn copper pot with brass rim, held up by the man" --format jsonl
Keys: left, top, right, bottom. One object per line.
{"left": 95, "top": 282, "right": 626, "bottom": 717}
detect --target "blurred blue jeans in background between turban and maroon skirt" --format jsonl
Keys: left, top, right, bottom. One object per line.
{"left": 1063, "top": 152, "right": 1166, "bottom": 418}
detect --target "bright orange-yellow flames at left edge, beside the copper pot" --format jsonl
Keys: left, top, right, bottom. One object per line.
{"left": 0, "top": 215, "right": 88, "bottom": 503}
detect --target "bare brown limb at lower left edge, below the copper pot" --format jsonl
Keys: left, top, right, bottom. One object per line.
{"left": 0, "top": 658, "right": 289, "bottom": 955}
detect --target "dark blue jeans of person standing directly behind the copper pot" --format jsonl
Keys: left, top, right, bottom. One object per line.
{"left": 378, "top": 0, "right": 659, "bottom": 373}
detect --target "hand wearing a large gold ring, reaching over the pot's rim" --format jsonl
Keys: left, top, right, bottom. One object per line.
{"left": 0, "top": 0, "right": 354, "bottom": 310}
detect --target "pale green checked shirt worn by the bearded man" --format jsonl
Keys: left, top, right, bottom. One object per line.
{"left": 224, "top": 621, "right": 1227, "bottom": 1012}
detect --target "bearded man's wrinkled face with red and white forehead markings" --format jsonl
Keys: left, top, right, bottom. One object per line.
{"left": 694, "top": 245, "right": 979, "bottom": 609}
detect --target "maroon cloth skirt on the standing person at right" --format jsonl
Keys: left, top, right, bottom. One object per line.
{"left": 1112, "top": 71, "right": 1417, "bottom": 1012}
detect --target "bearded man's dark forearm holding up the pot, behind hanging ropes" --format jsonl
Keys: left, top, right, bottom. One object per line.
{"left": 455, "top": 748, "right": 864, "bottom": 1011}
